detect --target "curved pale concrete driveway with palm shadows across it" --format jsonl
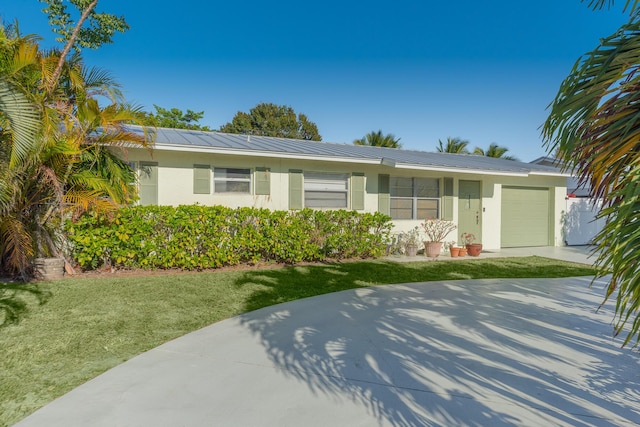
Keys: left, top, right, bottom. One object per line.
{"left": 18, "top": 270, "right": 640, "bottom": 427}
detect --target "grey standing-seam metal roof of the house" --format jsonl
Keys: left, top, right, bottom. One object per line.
{"left": 128, "top": 126, "right": 567, "bottom": 176}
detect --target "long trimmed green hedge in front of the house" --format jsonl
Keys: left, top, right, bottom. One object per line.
{"left": 66, "top": 205, "right": 391, "bottom": 270}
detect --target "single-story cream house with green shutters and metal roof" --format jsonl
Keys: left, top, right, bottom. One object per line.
{"left": 121, "top": 126, "right": 567, "bottom": 250}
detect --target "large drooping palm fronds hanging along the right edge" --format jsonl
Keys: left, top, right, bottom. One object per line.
{"left": 542, "top": 0, "right": 640, "bottom": 346}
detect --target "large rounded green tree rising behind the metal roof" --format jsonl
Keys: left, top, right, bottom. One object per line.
{"left": 220, "top": 103, "right": 322, "bottom": 141}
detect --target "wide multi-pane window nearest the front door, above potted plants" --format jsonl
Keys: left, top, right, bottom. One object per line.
{"left": 389, "top": 176, "right": 440, "bottom": 219}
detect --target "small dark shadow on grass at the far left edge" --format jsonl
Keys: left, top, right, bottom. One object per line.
{"left": 0, "top": 282, "right": 51, "bottom": 327}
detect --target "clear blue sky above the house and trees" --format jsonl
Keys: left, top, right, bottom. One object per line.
{"left": 0, "top": 0, "right": 627, "bottom": 161}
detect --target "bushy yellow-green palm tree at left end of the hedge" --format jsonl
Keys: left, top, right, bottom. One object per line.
{"left": 0, "top": 26, "right": 149, "bottom": 278}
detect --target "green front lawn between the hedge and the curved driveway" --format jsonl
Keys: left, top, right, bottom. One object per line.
{"left": 0, "top": 257, "right": 594, "bottom": 425}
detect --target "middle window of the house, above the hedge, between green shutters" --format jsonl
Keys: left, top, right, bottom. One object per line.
{"left": 304, "top": 172, "right": 349, "bottom": 209}
